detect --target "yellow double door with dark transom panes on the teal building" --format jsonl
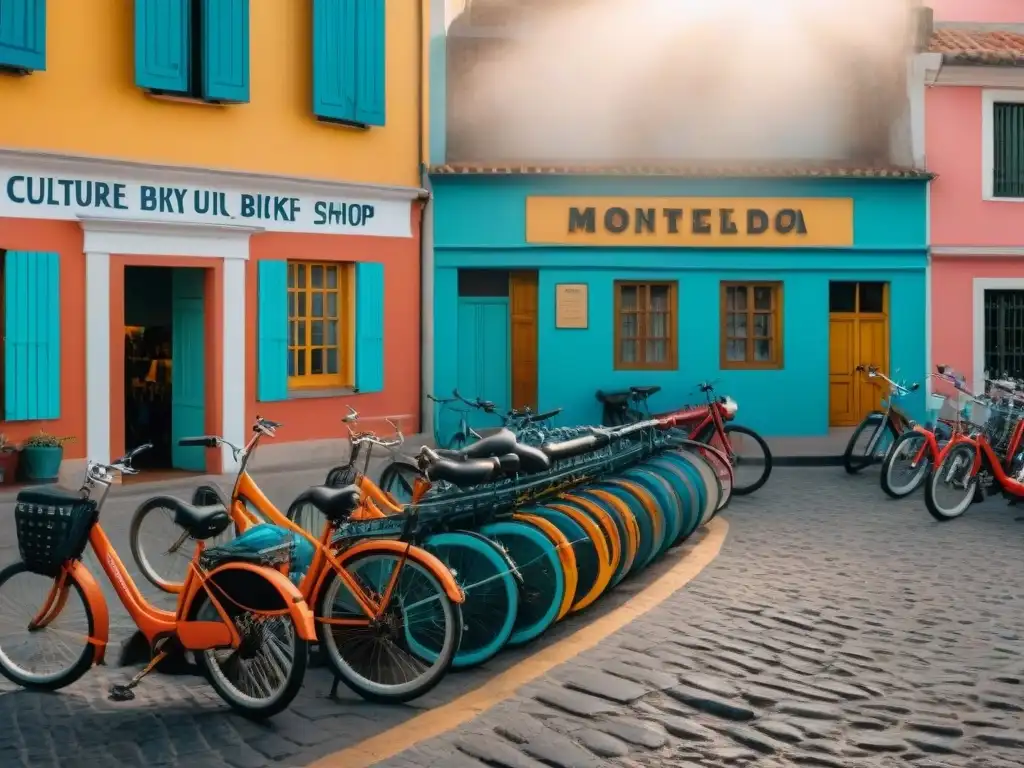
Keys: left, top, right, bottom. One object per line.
{"left": 828, "top": 283, "right": 891, "bottom": 427}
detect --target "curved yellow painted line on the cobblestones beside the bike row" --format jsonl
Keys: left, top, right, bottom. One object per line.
{"left": 309, "top": 517, "right": 729, "bottom": 768}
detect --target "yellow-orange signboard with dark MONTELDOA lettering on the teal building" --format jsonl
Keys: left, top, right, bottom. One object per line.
{"left": 526, "top": 198, "right": 853, "bottom": 248}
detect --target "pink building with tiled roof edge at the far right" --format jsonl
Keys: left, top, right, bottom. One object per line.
{"left": 919, "top": 0, "right": 1024, "bottom": 386}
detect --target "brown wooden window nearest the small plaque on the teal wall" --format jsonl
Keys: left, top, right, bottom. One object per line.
{"left": 615, "top": 281, "right": 678, "bottom": 371}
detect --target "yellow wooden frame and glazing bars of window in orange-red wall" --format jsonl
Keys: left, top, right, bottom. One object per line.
{"left": 288, "top": 259, "right": 355, "bottom": 390}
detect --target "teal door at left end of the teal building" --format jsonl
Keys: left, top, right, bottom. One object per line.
{"left": 458, "top": 297, "right": 512, "bottom": 429}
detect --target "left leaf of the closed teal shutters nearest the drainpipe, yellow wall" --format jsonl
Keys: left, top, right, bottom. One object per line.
{"left": 312, "top": 0, "right": 358, "bottom": 123}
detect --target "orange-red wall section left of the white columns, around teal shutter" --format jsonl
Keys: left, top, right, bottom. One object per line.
{"left": 0, "top": 218, "right": 87, "bottom": 459}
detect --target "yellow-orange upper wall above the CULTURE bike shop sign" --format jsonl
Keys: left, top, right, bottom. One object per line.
{"left": 0, "top": 0, "right": 426, "bottom": 186}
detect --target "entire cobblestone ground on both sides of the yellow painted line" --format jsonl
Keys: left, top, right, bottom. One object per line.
{"left": 0, "top": 469, "right": 1024, "bottom": 768}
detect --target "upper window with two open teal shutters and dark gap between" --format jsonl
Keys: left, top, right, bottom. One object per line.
{"left": 135, "top": 0, "right": 250, "bottom": 103}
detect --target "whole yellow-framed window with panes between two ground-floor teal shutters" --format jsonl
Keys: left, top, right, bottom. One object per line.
{"left": 288, "top": 261, "right": 354, "bottom": 389}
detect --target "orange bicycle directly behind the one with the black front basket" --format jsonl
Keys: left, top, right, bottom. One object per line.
{"left": 131, "top": 417, "right": 465, "bottom": 701}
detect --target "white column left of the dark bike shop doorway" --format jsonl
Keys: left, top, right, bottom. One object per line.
{"left": 85, "top": 253, "right": 115, "bottom": 462}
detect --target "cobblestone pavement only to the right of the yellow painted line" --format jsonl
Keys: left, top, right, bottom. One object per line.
{"left": 380, "top": 469, "right": 1024, "bottom": 768}
